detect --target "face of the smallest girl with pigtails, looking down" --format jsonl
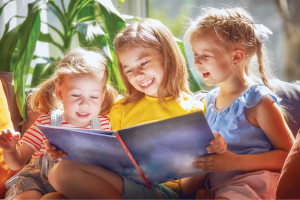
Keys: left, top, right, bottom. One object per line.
{"left": 55, "top": 75, "right": 105, "bottom": 127}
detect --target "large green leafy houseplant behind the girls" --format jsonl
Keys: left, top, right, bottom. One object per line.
{"left": 0, "top": 0, "right": 201, "bottom": 123}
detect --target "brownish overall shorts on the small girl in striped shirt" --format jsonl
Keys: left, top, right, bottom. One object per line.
{"left": 5, "top": 153, "right": 57, "bottom": 199}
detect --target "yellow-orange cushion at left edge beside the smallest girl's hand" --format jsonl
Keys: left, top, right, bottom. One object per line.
{"left": 0, "top": 80, "right": 17, "bottom": 199}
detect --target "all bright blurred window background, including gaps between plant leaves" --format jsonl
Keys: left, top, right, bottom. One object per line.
{"left": 0, "top": 0, "right": 300, "bottom": 89}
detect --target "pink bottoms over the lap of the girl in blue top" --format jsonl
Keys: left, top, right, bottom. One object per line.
{"left": 211, "top": 170, "right": 280, "bottom": 199}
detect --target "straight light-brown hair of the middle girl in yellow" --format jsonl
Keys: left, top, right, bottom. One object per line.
{"left": 114, "top": 19, "right": 191, "bottom": 104}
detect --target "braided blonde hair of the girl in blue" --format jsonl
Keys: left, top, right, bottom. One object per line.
{"left": 184, "top": 7, "right": 273, "bottom": 91}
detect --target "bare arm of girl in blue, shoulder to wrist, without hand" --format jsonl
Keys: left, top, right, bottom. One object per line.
{"left": 237, "top": 96, "right": 294, "bottom": 171}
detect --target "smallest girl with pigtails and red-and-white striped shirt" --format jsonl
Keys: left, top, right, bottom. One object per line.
{"left": 0, "top": 48, "right": 117, "bottom": 199}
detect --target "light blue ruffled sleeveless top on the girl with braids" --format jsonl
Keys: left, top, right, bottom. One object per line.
{"left": 205, "top": 85, "right": 281, "bottom": 154}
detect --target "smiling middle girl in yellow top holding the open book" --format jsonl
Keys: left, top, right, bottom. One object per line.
{"left": 43, "top": 19, "right": 224, "bottom": 199}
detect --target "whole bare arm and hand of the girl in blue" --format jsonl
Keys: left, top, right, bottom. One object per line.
{"left": 194, "top": 96, "right": 294, "bottom": 172}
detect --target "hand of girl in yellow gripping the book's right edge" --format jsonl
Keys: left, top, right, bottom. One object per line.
{"left": 206, "top": 132, "right": 227, "bottom": 154}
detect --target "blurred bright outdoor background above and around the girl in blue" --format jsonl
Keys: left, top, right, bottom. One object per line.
{"left": 147, "top": 0, "right": 300, "bottom": 88}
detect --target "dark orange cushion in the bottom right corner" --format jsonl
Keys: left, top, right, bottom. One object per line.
{"left": 276, "top": 130, "right": 300, "bottom": 199}
